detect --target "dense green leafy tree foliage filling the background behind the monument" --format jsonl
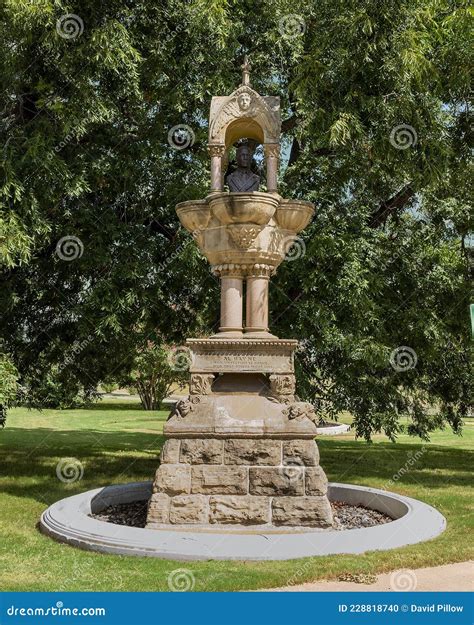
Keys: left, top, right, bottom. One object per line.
{"left": 0, "top": 0, "right": 473, "bottom": 438}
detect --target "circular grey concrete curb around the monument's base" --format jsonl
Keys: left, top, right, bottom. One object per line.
{"left": 40, "top": 482, "right": 446, "bottom": 560}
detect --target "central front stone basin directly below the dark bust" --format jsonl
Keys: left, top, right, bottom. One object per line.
{"left": 207, "top": 191, "right": 280, "bottom": 226}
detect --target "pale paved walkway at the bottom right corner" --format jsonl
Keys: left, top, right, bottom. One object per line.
{"left": 271, "top": 561, "right": 474, "bottom": 592}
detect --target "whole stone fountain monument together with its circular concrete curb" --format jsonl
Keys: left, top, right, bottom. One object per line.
{"left": 40, "top": 63, "right": 446, "bottom": 561}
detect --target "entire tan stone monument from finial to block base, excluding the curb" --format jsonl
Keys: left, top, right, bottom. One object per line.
{"left": 147, "top": 61, "right": 332, "bottom": 529}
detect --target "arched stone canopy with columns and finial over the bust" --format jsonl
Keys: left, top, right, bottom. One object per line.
{"left": 209, "top": 61, "right": 281, "bottom": 193}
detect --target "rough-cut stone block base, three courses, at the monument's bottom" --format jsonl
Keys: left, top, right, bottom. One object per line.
{"left": 147, "top": 437, "right": 332, "bottom": 529}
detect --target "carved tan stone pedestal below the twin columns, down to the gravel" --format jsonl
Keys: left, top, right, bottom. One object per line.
{"left": 147, "top": 338, "right": 332, "bottom": 529}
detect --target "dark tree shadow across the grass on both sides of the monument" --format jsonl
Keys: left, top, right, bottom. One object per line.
{"left": 0, "top": 419, "right": 473, "bottom": 503}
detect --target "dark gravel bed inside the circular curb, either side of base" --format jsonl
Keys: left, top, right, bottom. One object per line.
{"left": 89, "top": 501, "right": 393, "bottom": 530}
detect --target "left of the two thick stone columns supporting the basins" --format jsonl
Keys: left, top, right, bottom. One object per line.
{"left": 214, "top": 265, "right": 243, "bottom": 336}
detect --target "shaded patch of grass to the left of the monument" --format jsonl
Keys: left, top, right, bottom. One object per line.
{"left": 0, "top": 428, "right": 165, "bottom": 505}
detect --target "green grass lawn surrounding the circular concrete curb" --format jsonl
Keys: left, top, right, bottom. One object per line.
{"left": 0, "top": 400, "right": 474, "bottom": 591}
